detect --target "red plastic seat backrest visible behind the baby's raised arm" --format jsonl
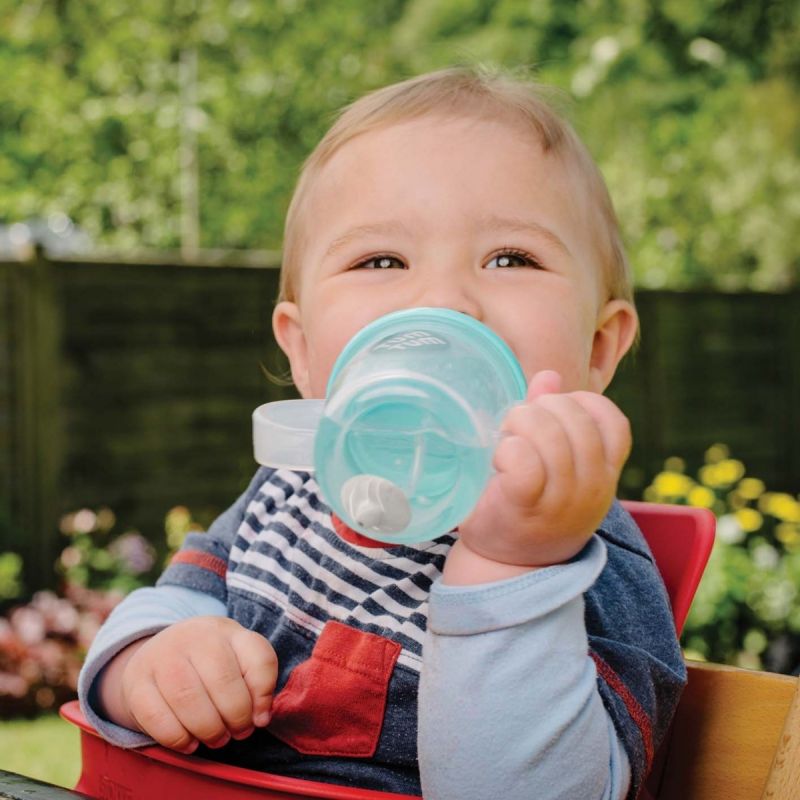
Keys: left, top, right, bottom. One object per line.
{"left": 622, "top": 500, "right": 716, "bottom": 633}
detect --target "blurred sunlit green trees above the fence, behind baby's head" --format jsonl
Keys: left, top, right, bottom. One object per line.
{"left": 0, "top": 0, "right": 800, "bottom": 289}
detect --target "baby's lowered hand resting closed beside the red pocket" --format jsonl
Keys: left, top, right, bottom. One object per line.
{"left": 100, "top": 617, "right": 278, "bottom": 753}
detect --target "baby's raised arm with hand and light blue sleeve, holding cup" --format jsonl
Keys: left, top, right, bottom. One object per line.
{"left": 419, "top": 372, "right": 631, "bottom": 800}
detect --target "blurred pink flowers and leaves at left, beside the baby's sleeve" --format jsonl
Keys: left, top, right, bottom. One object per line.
{"left": 0, "top": 506, "right": 202, "bottom": 719}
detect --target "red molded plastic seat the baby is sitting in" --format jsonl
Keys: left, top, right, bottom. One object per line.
{"left": 61, "top": 502, "right": 715, "bottom": 800}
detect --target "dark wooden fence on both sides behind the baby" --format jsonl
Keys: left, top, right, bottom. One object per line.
{"left": 0, "top": 253, "right": 800, "bottom": 588}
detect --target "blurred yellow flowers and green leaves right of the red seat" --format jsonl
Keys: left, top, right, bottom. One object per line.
{"left": 644, "top": 445, "right": 800, "bottom": 672}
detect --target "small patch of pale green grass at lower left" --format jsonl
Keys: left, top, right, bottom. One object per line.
{"left": 0, "top": 714, "right": 80, "bottom": 789}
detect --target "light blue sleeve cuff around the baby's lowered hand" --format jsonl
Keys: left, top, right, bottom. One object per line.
{"left": 78, "top": 586, "right": 226, "bottom": 747}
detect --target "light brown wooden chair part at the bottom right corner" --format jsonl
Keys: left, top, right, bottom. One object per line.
{"left": 648, "top": 662, "right": 800, "bottom": 800}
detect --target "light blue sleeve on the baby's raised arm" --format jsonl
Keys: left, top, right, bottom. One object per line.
{"left": 418, "top": 536, "right": 630, "bottom": 800}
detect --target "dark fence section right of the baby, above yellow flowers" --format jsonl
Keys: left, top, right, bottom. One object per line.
{"left": 610, "top": 292, "right": 800, "bottom": 494}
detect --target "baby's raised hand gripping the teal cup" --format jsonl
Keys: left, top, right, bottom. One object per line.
{"left": 445, "top": 371, "right": 631, "bottom": 582}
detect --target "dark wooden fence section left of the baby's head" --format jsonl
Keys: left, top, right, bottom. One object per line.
{"left": 0, "top": 262, "right": 289, "bottom": 588}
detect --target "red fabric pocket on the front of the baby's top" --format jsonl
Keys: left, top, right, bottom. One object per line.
{"left": 269, "top": 622, "right": 401, "bottom": 758}
